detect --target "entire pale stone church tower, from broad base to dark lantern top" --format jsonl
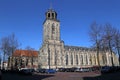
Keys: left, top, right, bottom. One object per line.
{"left": 39, "top": 9, "right": 64, "bottom": 68}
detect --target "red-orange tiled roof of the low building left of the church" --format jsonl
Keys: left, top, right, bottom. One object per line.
{"left": 12, "top": 50, "right": 38, "bottom": 57}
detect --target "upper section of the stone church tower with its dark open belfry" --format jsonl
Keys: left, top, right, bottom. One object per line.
{"left": 43, "top": 9, "right": 60, "bottom": 42}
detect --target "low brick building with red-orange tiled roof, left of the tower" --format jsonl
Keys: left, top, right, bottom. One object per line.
{"left": 8, "top": 50, "right": 38, "bottom": 69}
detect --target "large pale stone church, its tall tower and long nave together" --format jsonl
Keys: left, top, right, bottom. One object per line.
{"left": 38, "top": 9, "right": 119, "bottom": 69}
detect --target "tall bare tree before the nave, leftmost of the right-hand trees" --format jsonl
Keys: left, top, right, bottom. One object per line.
{"left": 89, "top": 22, "right": 102, "bottom": 66}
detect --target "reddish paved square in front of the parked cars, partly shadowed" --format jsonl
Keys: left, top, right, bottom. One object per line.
{"left": 2, "top": 72, "right": 120, "bottom": 80}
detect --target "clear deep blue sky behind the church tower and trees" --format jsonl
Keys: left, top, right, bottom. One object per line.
{"left": 0, "top": 0, "right": 120, "bottom": 50}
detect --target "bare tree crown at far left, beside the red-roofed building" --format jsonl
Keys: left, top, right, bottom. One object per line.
{"left": 1, "top": 34, "right": 19, "bottom": 69}
